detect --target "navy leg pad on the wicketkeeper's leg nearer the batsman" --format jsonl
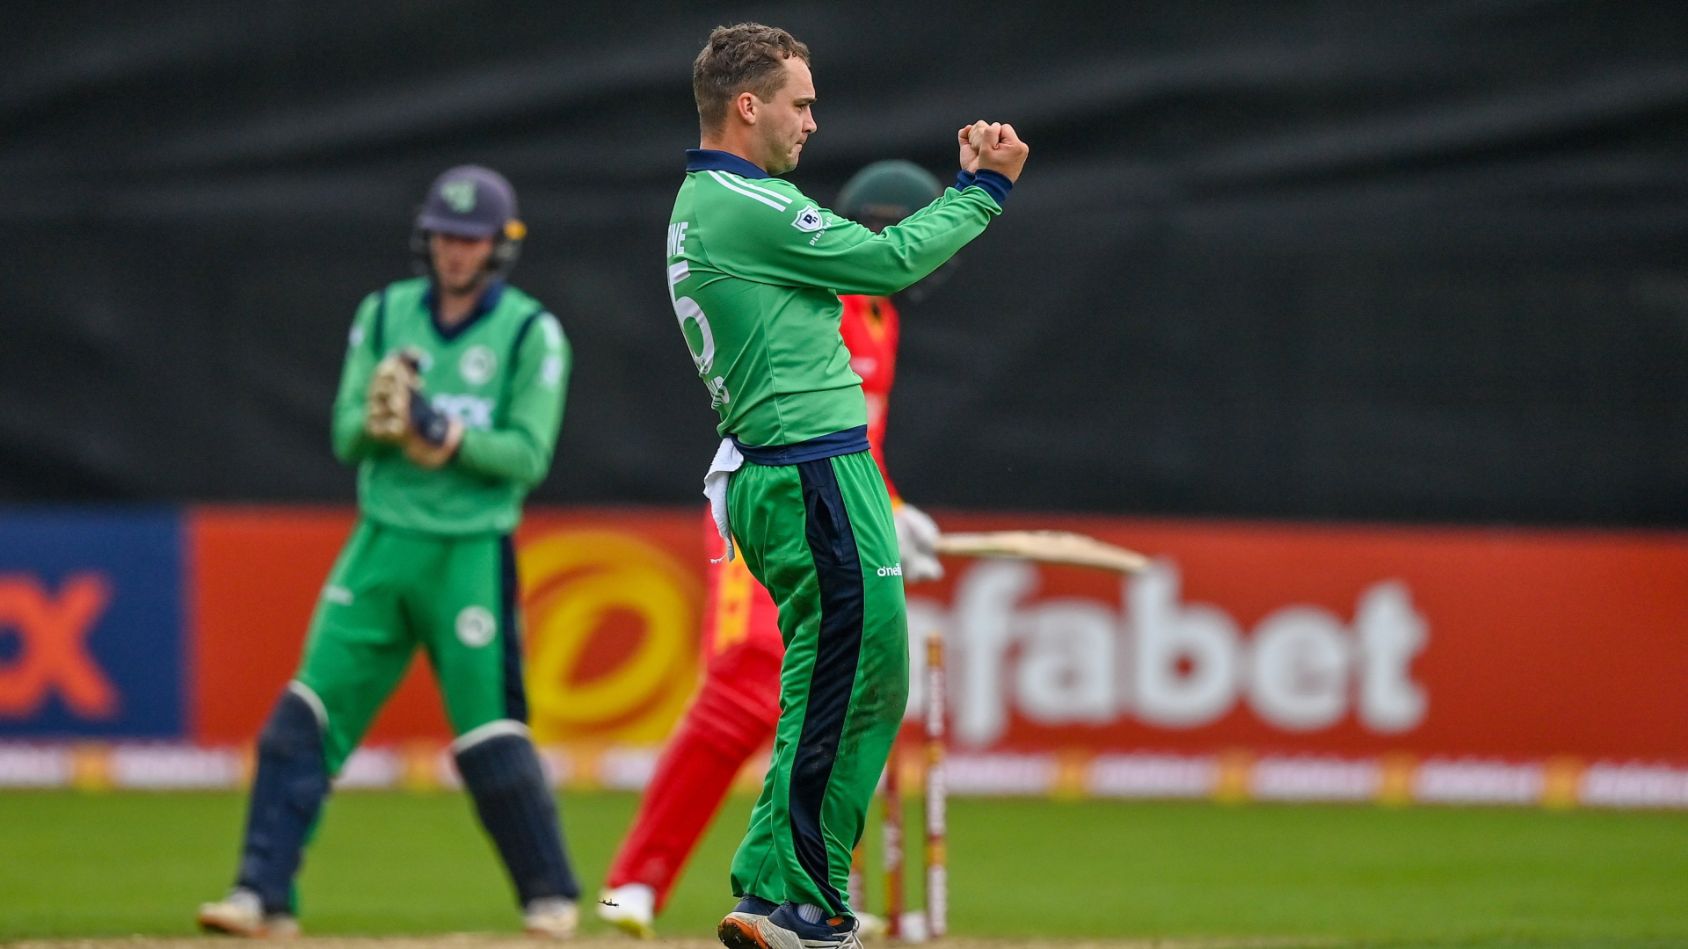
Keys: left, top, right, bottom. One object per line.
{"left": 456, "top": 723, "right": 581, "bottom": 905}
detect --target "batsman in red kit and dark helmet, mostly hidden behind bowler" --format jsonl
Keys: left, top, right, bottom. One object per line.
{"left": 598, "top": 160, "right": 944, "bottom": 937}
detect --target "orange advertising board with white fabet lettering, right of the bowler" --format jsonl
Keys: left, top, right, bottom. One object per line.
{"left": 910, "top": 517, "right": 1688, "bottom": 760}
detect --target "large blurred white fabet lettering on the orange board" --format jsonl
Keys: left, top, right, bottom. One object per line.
{"left": 908, "top": 562, "right": 1430, "bottom": 745}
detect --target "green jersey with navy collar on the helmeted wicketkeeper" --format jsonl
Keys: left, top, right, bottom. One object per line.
{"left": 334, "top": 277, "right": 572, "bottom": 537}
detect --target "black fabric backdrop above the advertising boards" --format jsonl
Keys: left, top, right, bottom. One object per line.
{"left": 0, "top": 0, "right": 1688, "bottom": 525}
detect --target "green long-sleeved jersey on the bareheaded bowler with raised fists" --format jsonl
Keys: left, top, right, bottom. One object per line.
{"left": 668, "top": 149, "right": 1006, "bottom": 446}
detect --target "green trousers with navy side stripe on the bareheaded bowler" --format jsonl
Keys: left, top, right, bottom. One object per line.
{"left": 728, "top": 451, "right": 908, "bottom": 915}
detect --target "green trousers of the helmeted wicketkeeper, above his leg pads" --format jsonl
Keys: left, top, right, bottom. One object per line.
{"left": 295, "top": 520, "right": 527, "bottom": 775}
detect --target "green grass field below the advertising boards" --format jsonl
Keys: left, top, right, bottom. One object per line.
{"left": 0, "top": 792, "right": 1688, "bottom": 947}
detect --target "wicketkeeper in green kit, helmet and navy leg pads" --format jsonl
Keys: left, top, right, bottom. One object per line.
{"left": 199, "top": 165, "right": 579, "bottom": 935}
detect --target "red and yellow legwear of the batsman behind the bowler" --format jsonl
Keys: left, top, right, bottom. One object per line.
{"left": 606, "top": 512, "right": 785, "bottom": 912}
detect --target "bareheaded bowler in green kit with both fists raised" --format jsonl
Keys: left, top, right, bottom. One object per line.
{"left": 667, "top": 24, "right": 1028, "bottom": 949}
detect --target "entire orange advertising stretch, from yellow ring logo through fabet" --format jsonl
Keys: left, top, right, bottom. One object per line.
{"left": 187, "top": 508, "right": 1688, "bottom": 763}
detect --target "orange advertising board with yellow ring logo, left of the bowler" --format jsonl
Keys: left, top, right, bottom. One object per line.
{"left": 187, "top": 508, "right": 704, "bottom": 745}
